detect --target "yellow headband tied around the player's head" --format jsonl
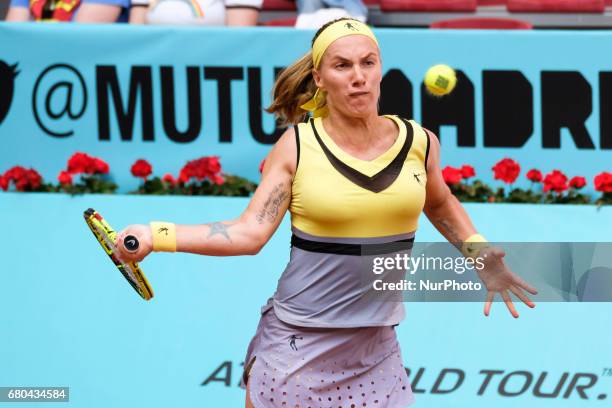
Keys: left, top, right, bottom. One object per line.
{"left": 300, "top": 20, "right": 378, "bottom": 118}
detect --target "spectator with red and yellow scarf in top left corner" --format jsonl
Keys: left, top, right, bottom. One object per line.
{"left": 6, "top": 0, "right": 129, "bottom": 23}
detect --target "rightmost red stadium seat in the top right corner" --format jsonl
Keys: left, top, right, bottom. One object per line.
{"left": 508, "top": 0, "right": 606, "bottom": 13}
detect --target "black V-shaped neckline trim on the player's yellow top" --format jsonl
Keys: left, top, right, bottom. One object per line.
{"left": 310, "top": 118, "right": 414, "bottom": 193}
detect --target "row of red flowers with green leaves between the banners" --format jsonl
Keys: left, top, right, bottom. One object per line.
{"left": 0, "top": 152, "right": 612, "bottom": 205}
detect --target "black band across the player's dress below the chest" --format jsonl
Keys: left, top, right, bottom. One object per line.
{"left": 291, "top": 234, "right": 414, "bottom": 255}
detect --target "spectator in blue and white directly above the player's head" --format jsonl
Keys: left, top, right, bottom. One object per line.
{"left": 295, "top": 0, "right": 368, "bottom": 28}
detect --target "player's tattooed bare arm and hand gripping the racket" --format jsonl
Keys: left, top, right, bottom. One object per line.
{"left": 117, "top": 129, "right": 297, "bottom": 261}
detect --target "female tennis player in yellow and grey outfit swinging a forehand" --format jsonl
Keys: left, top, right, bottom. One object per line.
{"left": 118, "top": 19, "right": 537, "bottom": 408}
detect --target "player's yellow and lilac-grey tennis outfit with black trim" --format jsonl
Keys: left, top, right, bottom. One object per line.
{"left": 244, "top": 115, "right": 429, "bottom": 408}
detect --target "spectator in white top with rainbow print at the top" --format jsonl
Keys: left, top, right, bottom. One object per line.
{"left": 130, "top": 0, "right": 263, "bottom": 26}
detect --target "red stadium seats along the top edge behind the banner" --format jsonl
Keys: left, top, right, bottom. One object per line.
{"left": 260, "top": 0, "right": 612, "bottom": 29}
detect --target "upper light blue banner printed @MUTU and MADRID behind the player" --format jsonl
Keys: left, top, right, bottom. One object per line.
{"left": 0, "top": 23, "right": 612, "bottom": 191}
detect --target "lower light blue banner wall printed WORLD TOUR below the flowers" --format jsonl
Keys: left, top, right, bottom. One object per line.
{"left": 0, "top": 193, "right": 612, "bottom": 408}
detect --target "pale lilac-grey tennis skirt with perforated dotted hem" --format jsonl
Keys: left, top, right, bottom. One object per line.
{"left": 240, "top": 306, "right": 414, "bottom": 408}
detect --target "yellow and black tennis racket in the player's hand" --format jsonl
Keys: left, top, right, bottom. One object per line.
{"left": 83, "top": 208, "right": 153, "bottom": 300}
